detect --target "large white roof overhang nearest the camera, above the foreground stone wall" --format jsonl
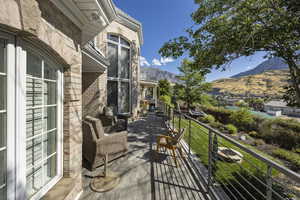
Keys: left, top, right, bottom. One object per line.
{"left": 52, "top": 0, "right": 117, "bottom": 45}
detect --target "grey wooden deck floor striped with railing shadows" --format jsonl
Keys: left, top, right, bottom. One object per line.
{"left": 81, "top": 114, "right": 209, "bottom": 200}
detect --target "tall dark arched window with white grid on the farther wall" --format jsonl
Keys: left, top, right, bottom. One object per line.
{"left": 107, "top": 34, "right": 131, "bottom": 113}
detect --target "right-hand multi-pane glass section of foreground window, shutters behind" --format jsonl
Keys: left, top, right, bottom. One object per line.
{"left": 26, "top": 52, "right": 58, "bottom": 197}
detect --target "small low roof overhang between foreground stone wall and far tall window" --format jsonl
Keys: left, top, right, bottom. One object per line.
{"left": 82, "top": 43, "right": 109, "bottom": 73}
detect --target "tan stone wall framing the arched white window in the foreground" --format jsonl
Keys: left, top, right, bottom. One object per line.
{"left": 0, "top": 0, "right": 82, "bottom": 199}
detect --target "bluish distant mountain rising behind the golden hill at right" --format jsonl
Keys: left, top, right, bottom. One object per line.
{"left": 231, "top": 57, "right": 288, "bottom": 78}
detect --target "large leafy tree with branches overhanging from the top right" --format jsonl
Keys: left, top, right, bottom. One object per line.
{"left": 159, "top": 0, "right": 300, "bottom": 105}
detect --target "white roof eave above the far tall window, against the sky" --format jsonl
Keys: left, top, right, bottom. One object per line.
{"left": 116, "top": 8, "right": 144, "bottom": 45}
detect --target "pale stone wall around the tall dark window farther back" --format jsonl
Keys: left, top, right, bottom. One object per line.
{"left": 97, "top": 22, "right": 140, "bottom": 118}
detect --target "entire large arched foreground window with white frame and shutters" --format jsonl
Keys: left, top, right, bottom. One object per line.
{"left": 0, "top": 32, "right": 63, "bottom": 200}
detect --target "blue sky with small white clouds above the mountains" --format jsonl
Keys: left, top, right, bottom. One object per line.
{"left": 114, "top": 0, "right": 265, "bottom": 81}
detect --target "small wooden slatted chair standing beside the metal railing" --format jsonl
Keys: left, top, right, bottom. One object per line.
{"left": 156, "top": 128, "right": 185, "bottom": 167}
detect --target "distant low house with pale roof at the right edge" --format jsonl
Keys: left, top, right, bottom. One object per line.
{"left": 264, "top": 100, "right": 300, "bottom": 117}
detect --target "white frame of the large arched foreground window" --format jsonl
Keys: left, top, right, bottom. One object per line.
{"left": 0, "top": 32, "right": 64, "bottom": 200}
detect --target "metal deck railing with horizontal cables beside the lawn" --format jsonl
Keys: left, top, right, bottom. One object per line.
{"left": 164, "top": 106, "right": 300, "bottom": 200}
